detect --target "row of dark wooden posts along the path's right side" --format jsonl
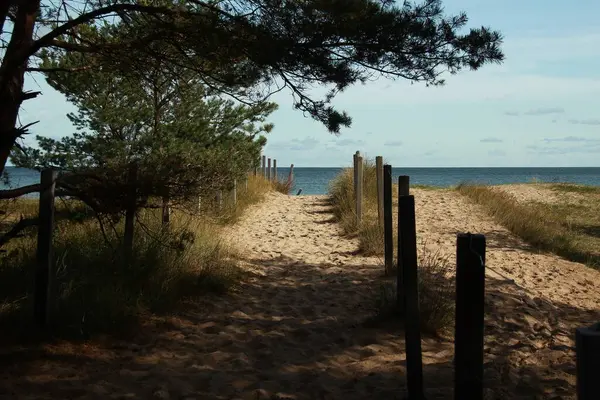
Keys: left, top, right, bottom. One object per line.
{"left": 353, "top": 151, "right": 600, "bottom": 400}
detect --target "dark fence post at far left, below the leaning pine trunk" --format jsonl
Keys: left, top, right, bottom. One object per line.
{"left": 33, "top": 169, "right": 58, "bottom": 327}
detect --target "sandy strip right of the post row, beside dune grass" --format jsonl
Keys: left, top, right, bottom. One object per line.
{"left": 414, "top": 190, "right": 600, "bottom": 399}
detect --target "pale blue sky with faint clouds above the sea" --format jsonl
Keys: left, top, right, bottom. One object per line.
{"left": 21, "top": 0, "right": 600, "bottom": 167}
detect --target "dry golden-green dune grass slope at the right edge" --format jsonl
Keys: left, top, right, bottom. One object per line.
{"left": 457, "top": 184, "right": 600, "bottom": 268}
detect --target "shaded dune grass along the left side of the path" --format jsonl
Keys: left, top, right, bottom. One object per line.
{"left": 0, "top": 173, "right": 271, "bottom": 338}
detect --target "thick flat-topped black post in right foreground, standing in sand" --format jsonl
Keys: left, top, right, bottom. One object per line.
{"left": 454, "top": 233, "right": 488, "bottom": 400}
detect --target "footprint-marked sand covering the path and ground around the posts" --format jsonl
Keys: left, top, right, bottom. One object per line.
{"left": 0, "top": 190, "right": 600, "bottom": 400}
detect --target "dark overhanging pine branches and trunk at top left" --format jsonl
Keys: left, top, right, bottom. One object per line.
{"left": 0, "top": 0, "right": 504, "bottom": 177}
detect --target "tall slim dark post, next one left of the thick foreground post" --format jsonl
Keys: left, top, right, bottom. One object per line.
{"left": 397, "top": 196, "right": 424, "bottom": 400}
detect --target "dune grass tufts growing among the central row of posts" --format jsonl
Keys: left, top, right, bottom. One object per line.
{"left": 329, "top": 161, "right": 454, "bottom": 333}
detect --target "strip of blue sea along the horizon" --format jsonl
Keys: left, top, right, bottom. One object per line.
{"left": 0, "top": 167, "right": 600, "bottom": 195}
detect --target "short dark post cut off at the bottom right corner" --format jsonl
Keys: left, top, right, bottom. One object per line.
{"left": 575, "top": 323, "right": 600, "bottom": 400}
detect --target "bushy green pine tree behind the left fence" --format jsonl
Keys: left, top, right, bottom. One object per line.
{"left": 12, "top": 48, "right": 277, "bottom": 214}
